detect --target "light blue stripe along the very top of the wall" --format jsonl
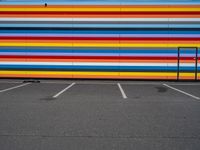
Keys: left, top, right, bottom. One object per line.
{"left": 1, "top": 0, "right": 199, "bottom": 4}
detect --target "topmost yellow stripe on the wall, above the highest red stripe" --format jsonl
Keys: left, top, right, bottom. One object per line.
{"left": 0, "top": 7, "right": 200, "bottom": 12}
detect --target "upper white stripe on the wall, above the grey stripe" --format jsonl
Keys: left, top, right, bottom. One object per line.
{"left": 0, "top": 18, "right": 200, "bottom": 22}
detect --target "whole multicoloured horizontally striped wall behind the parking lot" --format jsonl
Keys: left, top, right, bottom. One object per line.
{"left": 0, "top": 3, "right": 200, "bottom": 79}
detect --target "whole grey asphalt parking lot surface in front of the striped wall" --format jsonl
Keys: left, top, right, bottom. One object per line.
{"left": 0, "top": 79, "right": 200, "bottom": 150}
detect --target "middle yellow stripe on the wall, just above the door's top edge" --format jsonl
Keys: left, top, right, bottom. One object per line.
{"left": 0, "top": 42, "right": 200, "bottom": 47}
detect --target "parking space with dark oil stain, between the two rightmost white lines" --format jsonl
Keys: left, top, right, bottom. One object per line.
{"left": 123, "top": 84, "right": 200, "bottom": 103}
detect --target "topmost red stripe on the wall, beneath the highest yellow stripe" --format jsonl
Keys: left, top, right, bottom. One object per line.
{"left": 0, "top": 11, "right": 200, "bottom": 15}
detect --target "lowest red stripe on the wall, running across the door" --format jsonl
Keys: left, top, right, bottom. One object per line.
{"left": 0, "top": 55, "right": 193, "bottom": 60}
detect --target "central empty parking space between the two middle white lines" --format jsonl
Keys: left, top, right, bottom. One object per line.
{"left": 59, "top": 83, "right": 122, "bottom": 102}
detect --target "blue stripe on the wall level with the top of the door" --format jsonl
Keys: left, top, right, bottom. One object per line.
{"left": 0, "top": 48, "right": 179, "bottom": 53}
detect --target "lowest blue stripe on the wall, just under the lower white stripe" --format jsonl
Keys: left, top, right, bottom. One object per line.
{"left": 0, "top": 65, "right": 197, "bottom": 73}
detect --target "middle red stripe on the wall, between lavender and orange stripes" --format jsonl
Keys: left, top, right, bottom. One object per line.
{"left": 0, "top": 36, "right": 200, "bottom": 41}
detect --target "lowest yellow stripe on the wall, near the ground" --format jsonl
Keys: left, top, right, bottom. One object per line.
{"left": 0, "top": 70, "right": 194, "bottom": 76}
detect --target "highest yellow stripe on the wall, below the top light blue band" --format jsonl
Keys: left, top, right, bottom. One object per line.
{"left": 0, "top": 5, "right": 200, "bottom": 12}
